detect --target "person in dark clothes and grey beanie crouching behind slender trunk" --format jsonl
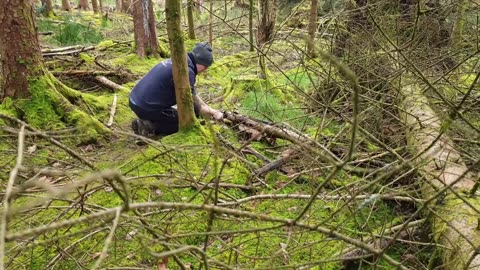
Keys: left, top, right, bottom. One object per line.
{"left": 129, "top": 42, "right": 223, "bottom": 137}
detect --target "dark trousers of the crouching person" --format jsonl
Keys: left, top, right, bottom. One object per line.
{"left": 129, "top": 101, "right": 200, "bottom": 135}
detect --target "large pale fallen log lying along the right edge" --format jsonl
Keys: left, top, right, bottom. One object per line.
{"left": 400, "top": 80, "right": 480, "bottom": 270}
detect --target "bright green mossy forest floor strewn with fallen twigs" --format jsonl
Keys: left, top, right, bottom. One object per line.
{"left": 0, "top": 4, "right": 477, "bottom": 269}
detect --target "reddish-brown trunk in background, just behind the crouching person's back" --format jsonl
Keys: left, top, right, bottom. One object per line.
{"left": 133, "top": 0, "right": 158, "bottom": 58}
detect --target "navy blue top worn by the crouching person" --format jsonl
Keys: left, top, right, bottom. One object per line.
{"left": 130, "top": 53, "right": 197, "bottom": 111}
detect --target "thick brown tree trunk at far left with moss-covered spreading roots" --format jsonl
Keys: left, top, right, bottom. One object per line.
{"left": 0, "top": 0, "right": 107, "bottom": 139}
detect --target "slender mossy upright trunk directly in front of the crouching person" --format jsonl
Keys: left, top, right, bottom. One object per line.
{"left": 165, "top": 0, "right": 196, "bottom": 130}
